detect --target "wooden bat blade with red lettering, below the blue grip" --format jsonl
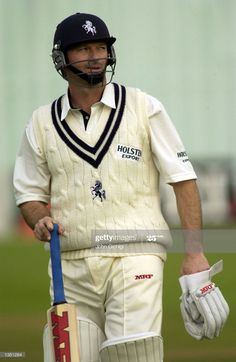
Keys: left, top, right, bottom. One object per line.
{"left": 47, "top": 303, "right": 80, "bottom": 362}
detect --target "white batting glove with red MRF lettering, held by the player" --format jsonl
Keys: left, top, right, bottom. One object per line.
{"left": 179, "top": 260, "right": 229, "bottom": 340}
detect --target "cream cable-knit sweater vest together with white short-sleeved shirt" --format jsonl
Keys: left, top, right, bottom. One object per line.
{"left": 14, "top": 84, "right": 196, "bottom": 258}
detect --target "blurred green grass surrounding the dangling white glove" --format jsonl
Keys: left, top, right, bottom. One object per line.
{"left": 163, "top": 254, "right": 236, "bottom": 362}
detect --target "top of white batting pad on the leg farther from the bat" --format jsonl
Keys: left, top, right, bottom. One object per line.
{"left": 100, "top": 332, "right": 163, "bottom": 362}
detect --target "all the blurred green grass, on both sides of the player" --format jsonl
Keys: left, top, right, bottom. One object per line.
{"left": 0, "top": 233, "right": 236, "bottom": 362}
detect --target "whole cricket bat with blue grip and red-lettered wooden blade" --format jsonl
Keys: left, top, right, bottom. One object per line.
{"left": 47, "top": 224, "right": 80, "bottom": 362}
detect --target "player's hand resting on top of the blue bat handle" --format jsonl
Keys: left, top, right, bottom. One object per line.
{"left": 34, "top": 216, "right": 64, "bottom": 241}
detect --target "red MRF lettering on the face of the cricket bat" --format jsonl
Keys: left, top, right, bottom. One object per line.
{"left": 51, "top": 312, "right": 71, "bottom": 362}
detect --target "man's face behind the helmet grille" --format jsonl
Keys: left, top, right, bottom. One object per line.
{"left": 67, "top": 42, "right": 108, "bottom": 74}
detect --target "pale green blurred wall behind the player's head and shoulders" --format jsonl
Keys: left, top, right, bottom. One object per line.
{"left": 0, "top": 0, "right": 236, "bottom": 235}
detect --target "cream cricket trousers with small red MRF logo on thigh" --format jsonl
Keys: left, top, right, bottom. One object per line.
{"left": 49, "top": 255, "right": 164, "bottom": 339}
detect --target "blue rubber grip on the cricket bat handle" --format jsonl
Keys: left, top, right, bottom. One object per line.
{"left": 50, "top": 224, "right": 66, "bottom": 305}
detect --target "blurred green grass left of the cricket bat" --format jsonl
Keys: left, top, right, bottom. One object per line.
{"left": 0, "top": 238, "right": 49, "bottom": 362}
